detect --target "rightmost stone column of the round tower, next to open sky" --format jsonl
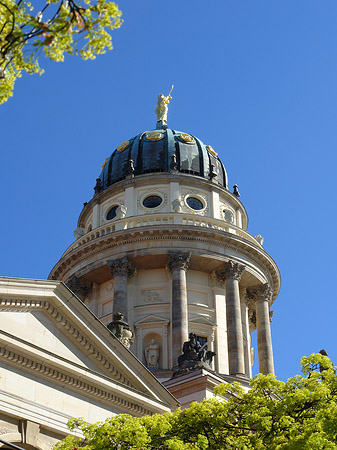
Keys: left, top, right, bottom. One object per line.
{"left": 247, "top": 283, "right": 274, "bottom": 375}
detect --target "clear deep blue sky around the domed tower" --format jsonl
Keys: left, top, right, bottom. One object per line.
{"left": 0, "top": 0, "right": 337, "bottom": 379}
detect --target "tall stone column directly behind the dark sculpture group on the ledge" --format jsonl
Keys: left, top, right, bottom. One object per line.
{"left": 167, "top": 251, "right": 191, "bottom": 367}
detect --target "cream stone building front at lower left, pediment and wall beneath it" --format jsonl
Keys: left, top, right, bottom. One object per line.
{"left": 0, "top": 277, "right": 177, "bottom": 450}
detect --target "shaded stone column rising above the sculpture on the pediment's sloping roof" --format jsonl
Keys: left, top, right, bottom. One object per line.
{"left": 107, "top": 256, "right": 135, "bottom": 322}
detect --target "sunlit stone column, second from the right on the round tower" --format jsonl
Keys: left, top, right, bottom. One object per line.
{"left": 216, "top": 261, "right": 245, "bottom": 375}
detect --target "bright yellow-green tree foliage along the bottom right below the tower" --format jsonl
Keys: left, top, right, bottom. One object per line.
{"left": 55, "top": 354, "right": 337, "bottom": 450}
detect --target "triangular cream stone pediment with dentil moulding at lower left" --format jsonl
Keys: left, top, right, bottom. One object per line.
{"left": 0, "top": 277, "right": 176, "bottom": 413}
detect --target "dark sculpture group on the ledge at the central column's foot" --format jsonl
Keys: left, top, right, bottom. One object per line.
{"left": 178, "top": 333, "right": 216, "bottom": 370}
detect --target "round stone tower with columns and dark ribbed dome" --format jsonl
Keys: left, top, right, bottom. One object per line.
{"left": 49, "top": 97, "right": 280, "bottom": 394}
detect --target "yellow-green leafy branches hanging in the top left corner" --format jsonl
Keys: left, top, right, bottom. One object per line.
{"left": 0, "top": 0, "right": 122, "bottom": 104}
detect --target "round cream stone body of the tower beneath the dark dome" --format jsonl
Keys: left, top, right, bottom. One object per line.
{"left": 50, "top": 172, "right": 280, "bottom": 381}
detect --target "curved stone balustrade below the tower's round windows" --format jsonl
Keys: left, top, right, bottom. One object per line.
{"left": 63, "top": 213, "right": 262, "bottom": 256}
